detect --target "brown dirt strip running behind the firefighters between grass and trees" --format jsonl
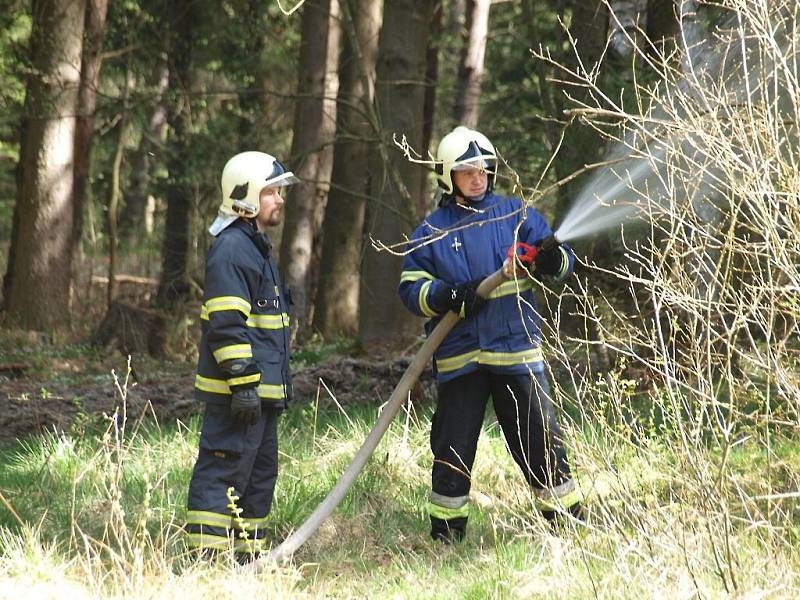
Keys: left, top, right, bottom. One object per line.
{"left": 0, "top": 358, "right": 433, "bottom": 443}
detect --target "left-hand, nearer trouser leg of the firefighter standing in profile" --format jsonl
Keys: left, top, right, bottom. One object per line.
{"left": 186, "top": 403, "right": 267, "bottom": 549}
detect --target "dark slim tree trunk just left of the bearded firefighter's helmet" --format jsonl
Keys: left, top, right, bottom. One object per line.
{"left": 156, "top": 2, "right": 195, "bottom": 308}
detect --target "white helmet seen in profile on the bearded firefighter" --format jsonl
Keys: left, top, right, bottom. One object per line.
{"left": 208, "top": 152, "right": 297, "bottom": 236}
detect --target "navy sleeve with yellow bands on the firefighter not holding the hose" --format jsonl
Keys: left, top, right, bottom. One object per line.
{"left": 201, "top": 245, "right": 261, "bottom": 387}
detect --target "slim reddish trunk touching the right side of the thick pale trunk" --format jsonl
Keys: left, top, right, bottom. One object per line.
{"left": 72, "top": 0, "right": 108, "bottom": 255}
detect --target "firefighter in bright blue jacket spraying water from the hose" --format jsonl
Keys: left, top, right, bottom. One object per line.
{"left": 399, "top": 127, "right": 581, "bottom": 543}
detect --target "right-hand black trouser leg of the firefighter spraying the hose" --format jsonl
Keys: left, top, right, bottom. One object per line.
{"left": 492, "top": 373, "right": 580, "bottom": 518}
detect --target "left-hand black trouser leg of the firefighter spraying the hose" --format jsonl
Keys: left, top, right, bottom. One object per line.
{"left": 428, "top": 372, "right": 489, "bottom": 541}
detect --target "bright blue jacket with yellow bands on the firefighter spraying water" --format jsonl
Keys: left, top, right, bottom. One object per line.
{"left": 399, "top": 194, "right": 575, "bottom": 381}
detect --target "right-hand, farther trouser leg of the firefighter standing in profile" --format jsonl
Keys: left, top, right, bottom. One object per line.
{"left": 240, "top": 409, "right": 281, "bottom": 540}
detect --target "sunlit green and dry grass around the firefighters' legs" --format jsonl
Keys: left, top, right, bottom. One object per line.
{"left": 0, "top": 386, "right": 800, "bottom": 599}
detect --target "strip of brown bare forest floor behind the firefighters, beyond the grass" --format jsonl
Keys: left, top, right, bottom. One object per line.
{"left": 0, "top": 346, "right": 432, "bottom": 443}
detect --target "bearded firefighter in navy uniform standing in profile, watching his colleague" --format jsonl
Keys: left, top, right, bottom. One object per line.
{"left": 186, "top": 152, "right": 297, "bottom": 558}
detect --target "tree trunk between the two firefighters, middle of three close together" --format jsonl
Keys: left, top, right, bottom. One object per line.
{"left": 314, "top": 0, "right": 381, "bottom": 338}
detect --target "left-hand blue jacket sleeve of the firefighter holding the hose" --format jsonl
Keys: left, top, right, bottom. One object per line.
{"left": 397, "top": 226, "right": 448, "bottom": 317}
